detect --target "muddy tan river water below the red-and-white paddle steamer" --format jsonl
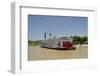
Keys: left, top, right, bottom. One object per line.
{"left": 28, "top": 46, "right": 88, "bottom": 61}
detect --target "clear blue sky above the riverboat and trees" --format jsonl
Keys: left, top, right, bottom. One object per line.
{"left": 28, "top": 15, "right": 88, "bottom": 40}
